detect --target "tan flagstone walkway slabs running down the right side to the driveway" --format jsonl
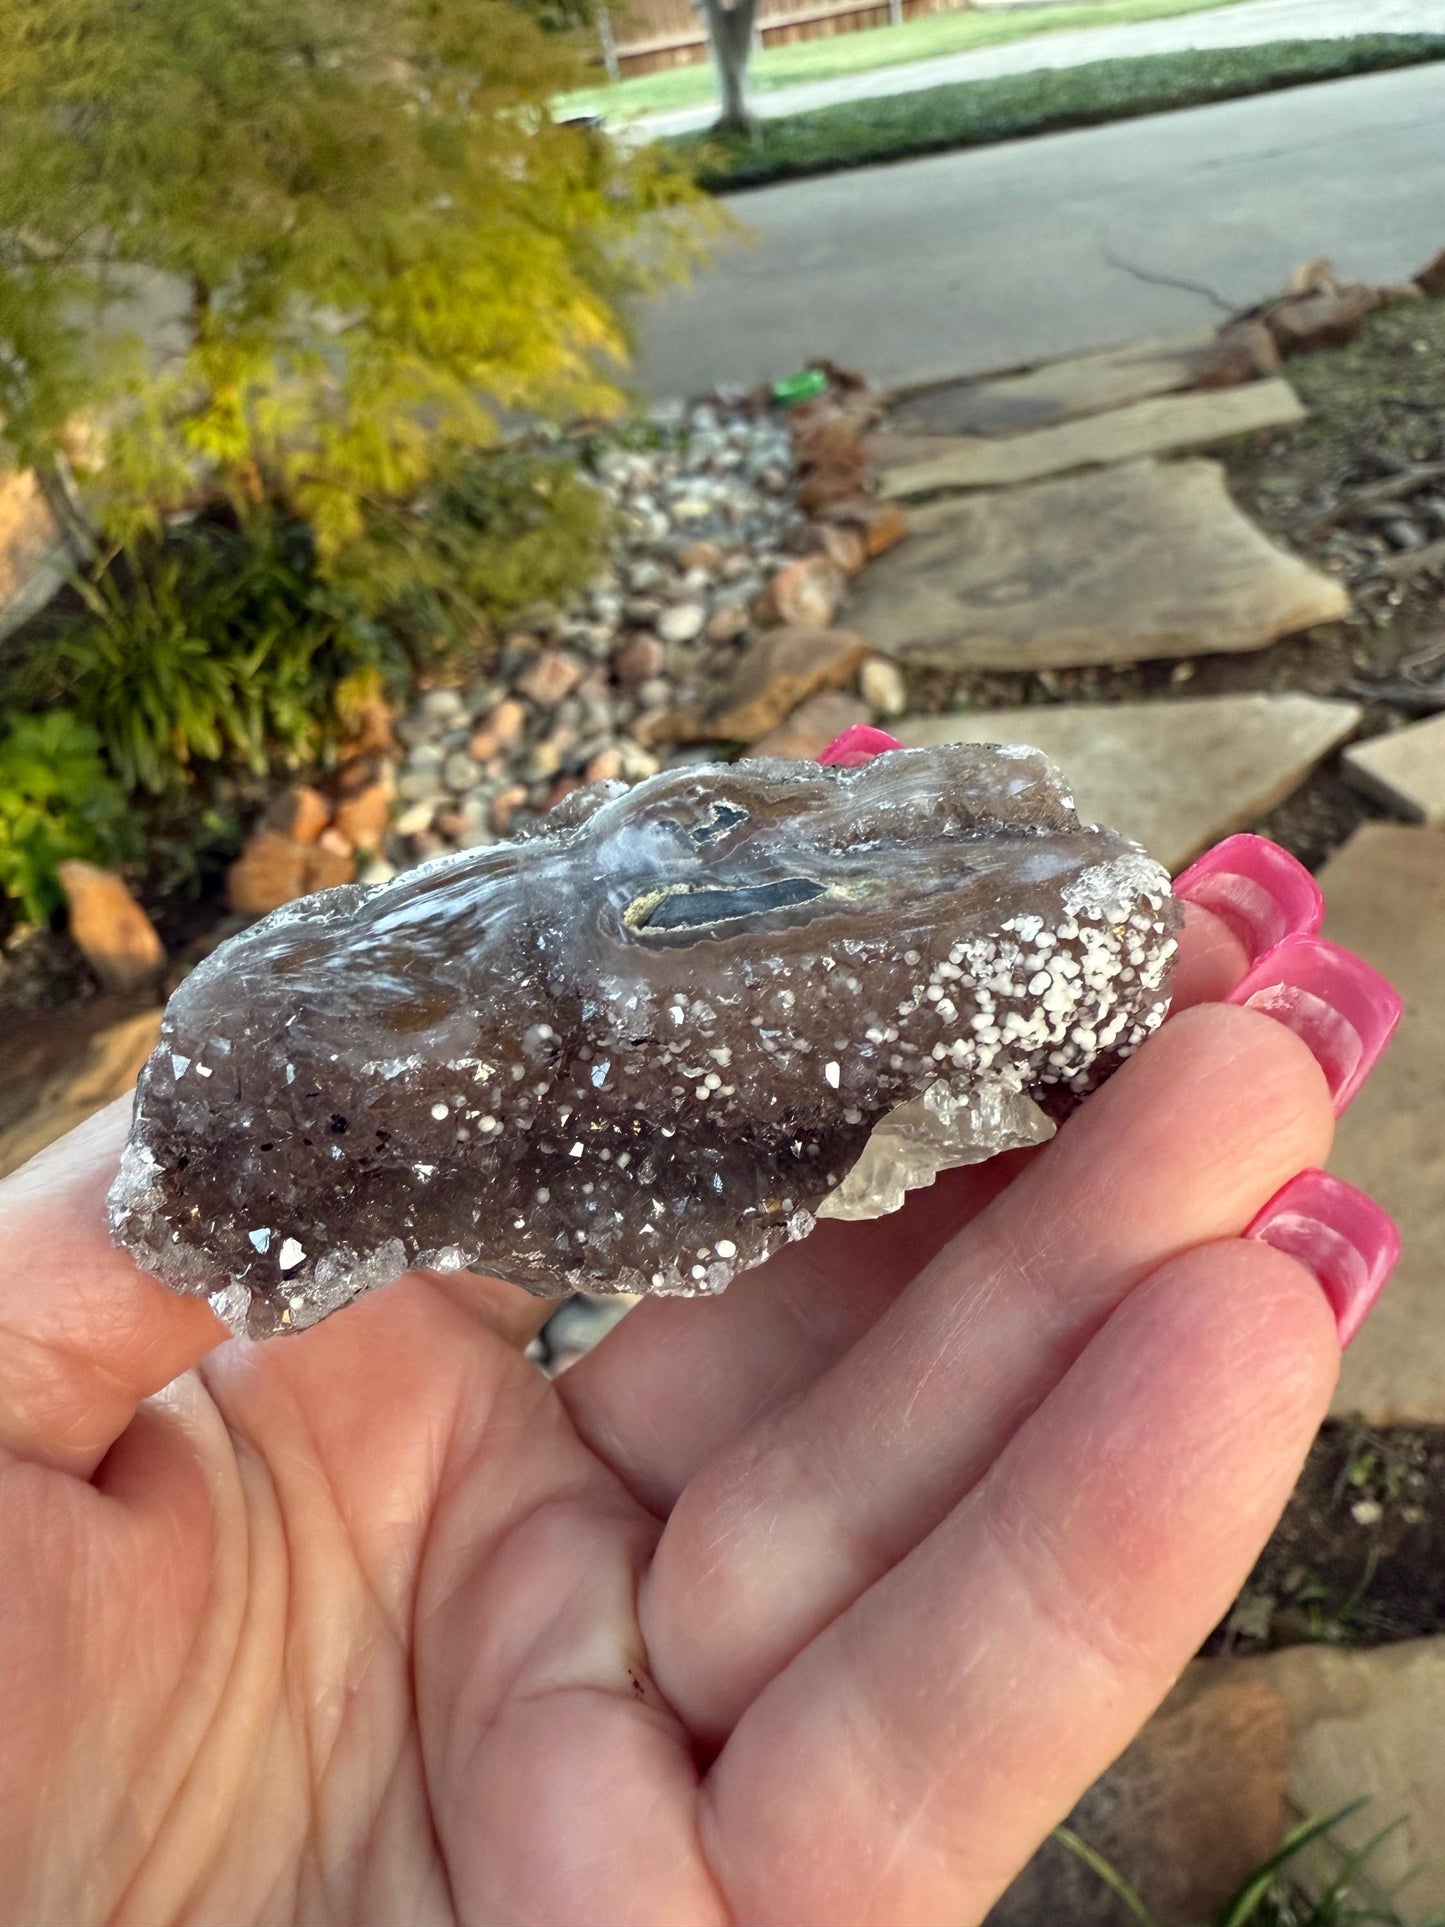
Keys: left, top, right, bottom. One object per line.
{"left": 844, "top": 337, "right": 1445, "bottom": 1927}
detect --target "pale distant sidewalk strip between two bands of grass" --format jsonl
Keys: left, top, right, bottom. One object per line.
{"left": 630, "top": 0, "right": 1445, "bottom": 135}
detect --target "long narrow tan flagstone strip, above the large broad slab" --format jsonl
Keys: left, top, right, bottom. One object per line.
{"left": 879, "top": 378, "right": 1306, "bottom": 501}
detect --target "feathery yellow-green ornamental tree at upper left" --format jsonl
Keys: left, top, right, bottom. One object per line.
{"left": 0, "top": 0, "right": 701, "bottom": 572}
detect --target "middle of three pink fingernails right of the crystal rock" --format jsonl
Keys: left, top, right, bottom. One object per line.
{"left": 1225, "top": 937, "right": 1405, "bottom": 1118}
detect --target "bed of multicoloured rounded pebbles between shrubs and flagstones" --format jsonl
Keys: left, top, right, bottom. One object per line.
{"left": 362, "top": 401, "right": 820, "bottom": 883}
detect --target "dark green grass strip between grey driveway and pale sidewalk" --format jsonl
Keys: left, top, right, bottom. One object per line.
{"left": 667, "top": 33, "right": 1445, "bottom": 193}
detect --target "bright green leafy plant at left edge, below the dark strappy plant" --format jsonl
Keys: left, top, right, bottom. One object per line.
{"left": 0, "top": 709, "right": 131, "bottom": 923}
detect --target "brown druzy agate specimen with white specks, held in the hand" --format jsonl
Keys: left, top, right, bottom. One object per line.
{"left": 110, "top": 744, "right": 1179, "bottom": 1337}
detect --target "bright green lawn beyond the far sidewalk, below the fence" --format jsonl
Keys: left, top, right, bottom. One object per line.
{"left": 557, "top": 0, "right": 1237, "bottom": 116}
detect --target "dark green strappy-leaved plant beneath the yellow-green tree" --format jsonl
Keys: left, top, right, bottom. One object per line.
{"left": 19, "top": 516, "right": 403, "bottom": 796}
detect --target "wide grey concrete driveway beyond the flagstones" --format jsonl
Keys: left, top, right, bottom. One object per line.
{"left": 638, "top": 63, "right": 1445, "bottom": 395}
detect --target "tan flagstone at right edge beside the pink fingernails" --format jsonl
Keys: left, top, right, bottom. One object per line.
{"left": 1320, "top": 823, "right": 1445, "bottom": 1425}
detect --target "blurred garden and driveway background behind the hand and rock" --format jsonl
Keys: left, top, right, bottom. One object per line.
{"left": 0, "top": 0, "right": 1445, "bottom": 1927}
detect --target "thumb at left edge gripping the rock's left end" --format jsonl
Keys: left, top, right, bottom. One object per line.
{"left": 0, "top": 1096, "right": 229, "bottom": 1478}
